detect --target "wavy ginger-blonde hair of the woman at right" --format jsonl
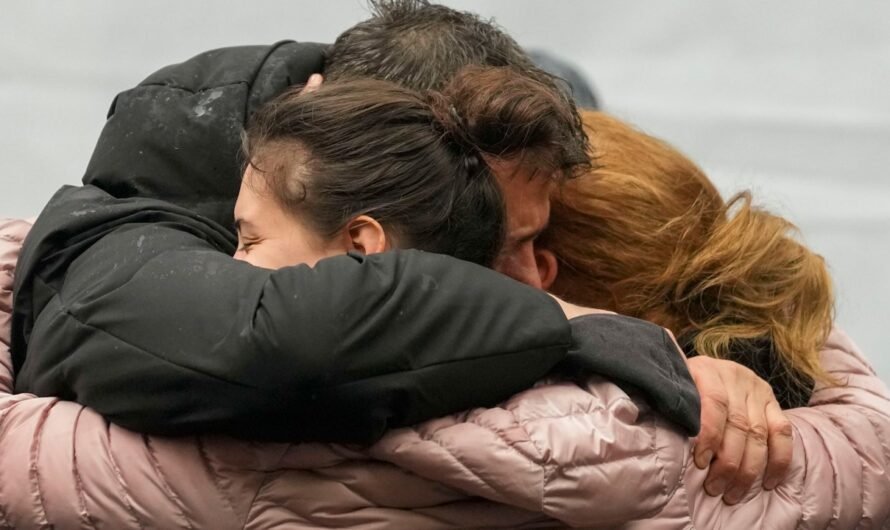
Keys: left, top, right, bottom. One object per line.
{"left": 541, "top": 112, "right": 834, "bottom": 392}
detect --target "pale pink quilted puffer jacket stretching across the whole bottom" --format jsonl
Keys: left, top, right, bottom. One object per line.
{"left": 0, "top": 217, "right": 890, "bottom": 530}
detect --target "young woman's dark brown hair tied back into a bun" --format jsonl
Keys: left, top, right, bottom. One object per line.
{"left": 244, "top": 68, "right": 586, "bottom": 265}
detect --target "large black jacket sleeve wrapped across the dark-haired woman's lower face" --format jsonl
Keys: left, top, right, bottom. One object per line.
{"left": 16, "top": 190, "right": 571, "bottom": 442}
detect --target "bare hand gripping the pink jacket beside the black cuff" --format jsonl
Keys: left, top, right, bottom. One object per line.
{"left": 687, "top": 356, "right": 792, "bottom": 504}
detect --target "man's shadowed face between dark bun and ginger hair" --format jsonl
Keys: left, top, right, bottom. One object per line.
{"left": 488, "top": 160, "right": 555, "bottom": 289}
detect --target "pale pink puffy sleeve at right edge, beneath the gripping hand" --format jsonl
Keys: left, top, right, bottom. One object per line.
{"left": 683, "top": 330, "right": 890, "bottom": 529}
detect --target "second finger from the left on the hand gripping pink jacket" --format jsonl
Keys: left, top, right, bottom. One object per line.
{"left": 705, "top": 372, "right": 749, "bottom": 496}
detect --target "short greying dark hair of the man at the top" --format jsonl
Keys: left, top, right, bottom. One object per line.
{"left": 324, "top": 0, "right": 589, "bottom": 173}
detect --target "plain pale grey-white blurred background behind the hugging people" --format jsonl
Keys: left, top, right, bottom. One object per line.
{"left": 0, "top": 0, "right": 890, "bottom": 381}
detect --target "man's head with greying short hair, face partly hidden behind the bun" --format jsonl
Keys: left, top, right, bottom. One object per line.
{"left": 325, "top": 0, "right": 589, "bottom": 287}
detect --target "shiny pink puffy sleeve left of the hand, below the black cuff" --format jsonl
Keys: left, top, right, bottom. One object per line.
{"left": 371, "top": 376, "right": 690, "bottom": 528}
